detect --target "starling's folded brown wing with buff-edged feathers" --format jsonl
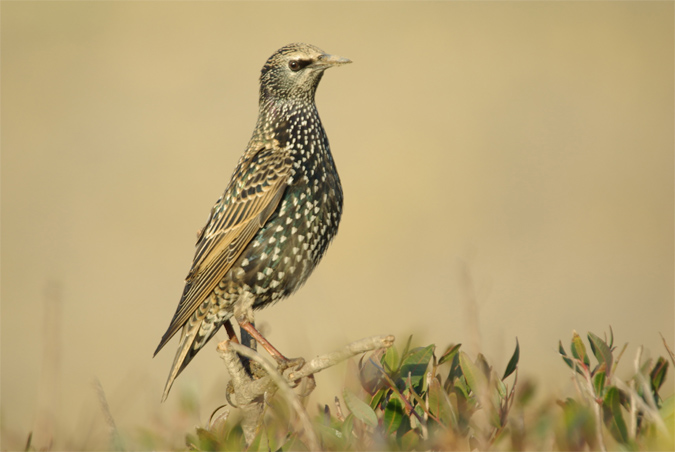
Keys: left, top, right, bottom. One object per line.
{"left": 155, "top": 143, "right": 292, "bottom": 354}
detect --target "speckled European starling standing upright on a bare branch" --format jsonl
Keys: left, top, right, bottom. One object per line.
{"left": 155, "top": 43, "right": 351, "bottom": 401}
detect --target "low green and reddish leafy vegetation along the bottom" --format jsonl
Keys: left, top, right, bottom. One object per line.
{"left": 173, "top": 328, "right": 675, "bottom": 451}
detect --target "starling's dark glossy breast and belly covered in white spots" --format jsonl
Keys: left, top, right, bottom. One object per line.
{"left": 230, "top": 123, "right": 342, "bottom": 308}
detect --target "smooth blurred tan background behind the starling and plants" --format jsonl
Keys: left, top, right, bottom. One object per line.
{"left": 0, "top": 2, "right": 675, "bottom": 450}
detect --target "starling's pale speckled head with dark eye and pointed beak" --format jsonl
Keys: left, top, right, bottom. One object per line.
{"left": 260, "top": 43, "right": 351, "bottom": 101}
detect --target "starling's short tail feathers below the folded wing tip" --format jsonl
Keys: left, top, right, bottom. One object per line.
{"left": 162, "top": 315, "right": 224, "bottom": 402}
